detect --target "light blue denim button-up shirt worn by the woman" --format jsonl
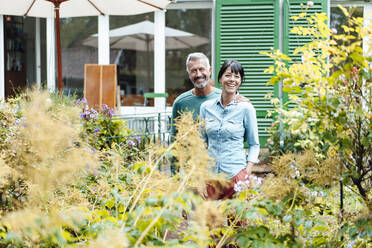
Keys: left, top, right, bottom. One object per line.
{"left": 200, "top": 98, "right": 260, "bottom": 178}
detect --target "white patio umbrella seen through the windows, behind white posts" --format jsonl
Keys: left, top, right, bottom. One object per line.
{"left": 83, "top": 21, "right": 209, "bottom": 51}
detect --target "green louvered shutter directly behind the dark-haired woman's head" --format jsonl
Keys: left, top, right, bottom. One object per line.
{"left": 215, "top": 0, "right": 279, "bottom": 147}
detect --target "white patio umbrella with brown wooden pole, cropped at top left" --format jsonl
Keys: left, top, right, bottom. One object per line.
{"left": 0, "top": 0, "right": 170, "bottom": 92}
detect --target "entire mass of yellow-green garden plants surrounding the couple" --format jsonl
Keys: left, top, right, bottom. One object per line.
{"left": 0, "top": 5, "right": 372, "bottom": 248}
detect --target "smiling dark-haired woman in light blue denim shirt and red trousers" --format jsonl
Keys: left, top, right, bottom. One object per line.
{"left": 200, "top": 60, "right": 260, "bottom": 199}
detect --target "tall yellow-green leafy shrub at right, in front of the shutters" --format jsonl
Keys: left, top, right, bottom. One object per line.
{"left": 265, "top": 7, "right": 372, "bottom": 209}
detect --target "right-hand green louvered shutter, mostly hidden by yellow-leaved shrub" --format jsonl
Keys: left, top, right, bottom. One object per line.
{"left": 283, "top": 0, "right": 328, "bottom": 105}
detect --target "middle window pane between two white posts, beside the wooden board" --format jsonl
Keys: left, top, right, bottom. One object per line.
{"left": 110, "top": 13, "right": 154, "bottom": 106}
